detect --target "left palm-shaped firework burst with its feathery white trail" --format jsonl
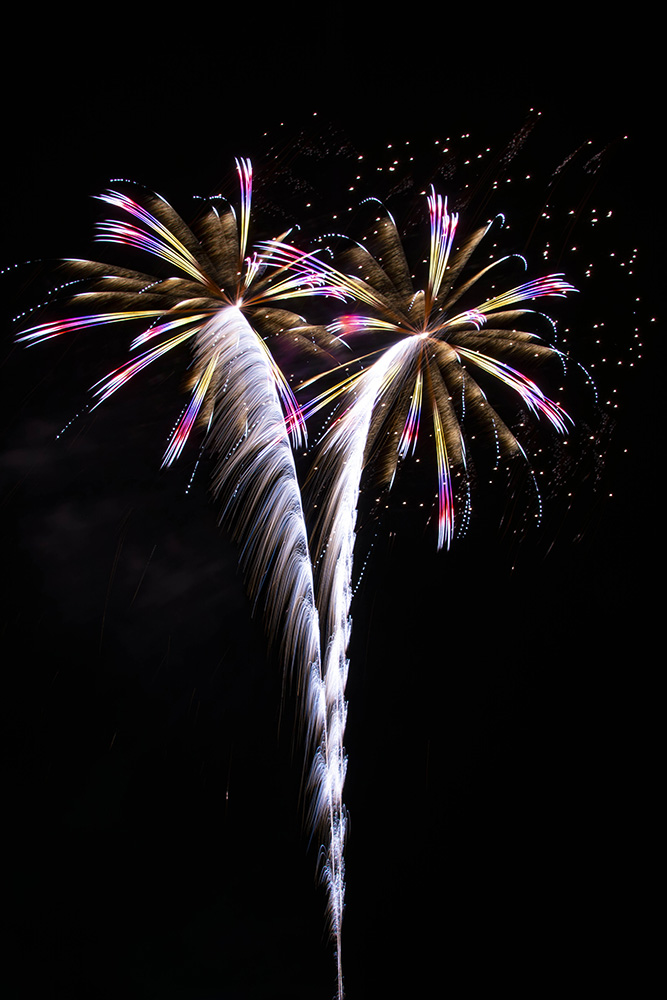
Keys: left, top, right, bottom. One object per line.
{"left": 19, "top": 160, "right": 327, "bottom": 704}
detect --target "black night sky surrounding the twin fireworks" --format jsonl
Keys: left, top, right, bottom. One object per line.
{"left": 2, "top": 25, "right": 662, "bottom": 1000}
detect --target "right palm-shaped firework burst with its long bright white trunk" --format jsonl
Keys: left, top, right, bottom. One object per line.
{"left": 265, "top": 186, "right": 574, "bottom": 992}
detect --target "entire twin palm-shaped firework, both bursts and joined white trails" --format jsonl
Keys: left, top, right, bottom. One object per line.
{"left": 10, "top": 123, "right": 640, "bottom": 993}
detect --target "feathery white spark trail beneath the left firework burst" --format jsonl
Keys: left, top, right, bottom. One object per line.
{"left": 195, "top": 306, "right": 320, "bottom": 712}
